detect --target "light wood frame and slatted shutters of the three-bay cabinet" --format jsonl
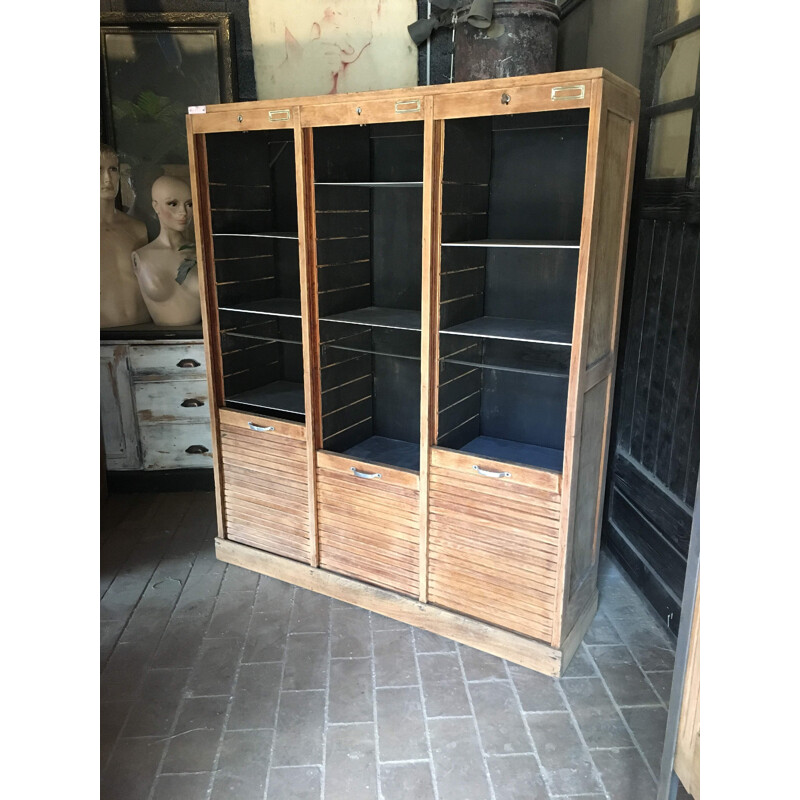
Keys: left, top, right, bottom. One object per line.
{"left": 187, "top": 69, "right": 638, "bottom": 675}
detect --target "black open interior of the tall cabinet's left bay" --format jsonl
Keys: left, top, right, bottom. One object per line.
{"left": 206, "top": 130, "right": 305, "bottom": 421}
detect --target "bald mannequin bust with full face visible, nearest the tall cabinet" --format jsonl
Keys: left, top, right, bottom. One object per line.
{"left": 131, "top": 175, "right": 200, "bottom": 325}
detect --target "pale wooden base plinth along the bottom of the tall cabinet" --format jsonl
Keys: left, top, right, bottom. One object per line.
{"left": 216, "top": 538, "right": 597, "bottom": 677}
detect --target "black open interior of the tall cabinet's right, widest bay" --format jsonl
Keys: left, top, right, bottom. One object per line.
{"left": 436, "top": 109, "right": 588, "bottom": 471}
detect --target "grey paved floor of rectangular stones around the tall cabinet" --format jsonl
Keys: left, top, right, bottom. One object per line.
{"left": 100, "top": 492, "right": 674, "bottom": 800}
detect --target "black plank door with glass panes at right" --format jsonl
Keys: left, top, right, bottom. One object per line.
{"left": 603, "top": 0, "right": 700, "bottom": 633}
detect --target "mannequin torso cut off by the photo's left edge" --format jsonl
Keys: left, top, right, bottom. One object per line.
{"left": 100, "top": 144, "right": 150, "bottom": 328}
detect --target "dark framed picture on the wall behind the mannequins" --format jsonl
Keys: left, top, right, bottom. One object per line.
{"left": 100, "top": 12, "right": 236, "bottom": 236}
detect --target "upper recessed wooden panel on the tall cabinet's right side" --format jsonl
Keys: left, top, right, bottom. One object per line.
{"left": 586, "top": 111, "right": 634, "bottom": 366}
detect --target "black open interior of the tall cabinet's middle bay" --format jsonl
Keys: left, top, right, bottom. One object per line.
{"left": 314, "top": 121, "right": 423, "bottom": 470}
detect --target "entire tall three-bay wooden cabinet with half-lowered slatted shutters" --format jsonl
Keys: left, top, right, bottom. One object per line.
{"left": 187, "top": 70, "right": 638, "bottom": 674}
